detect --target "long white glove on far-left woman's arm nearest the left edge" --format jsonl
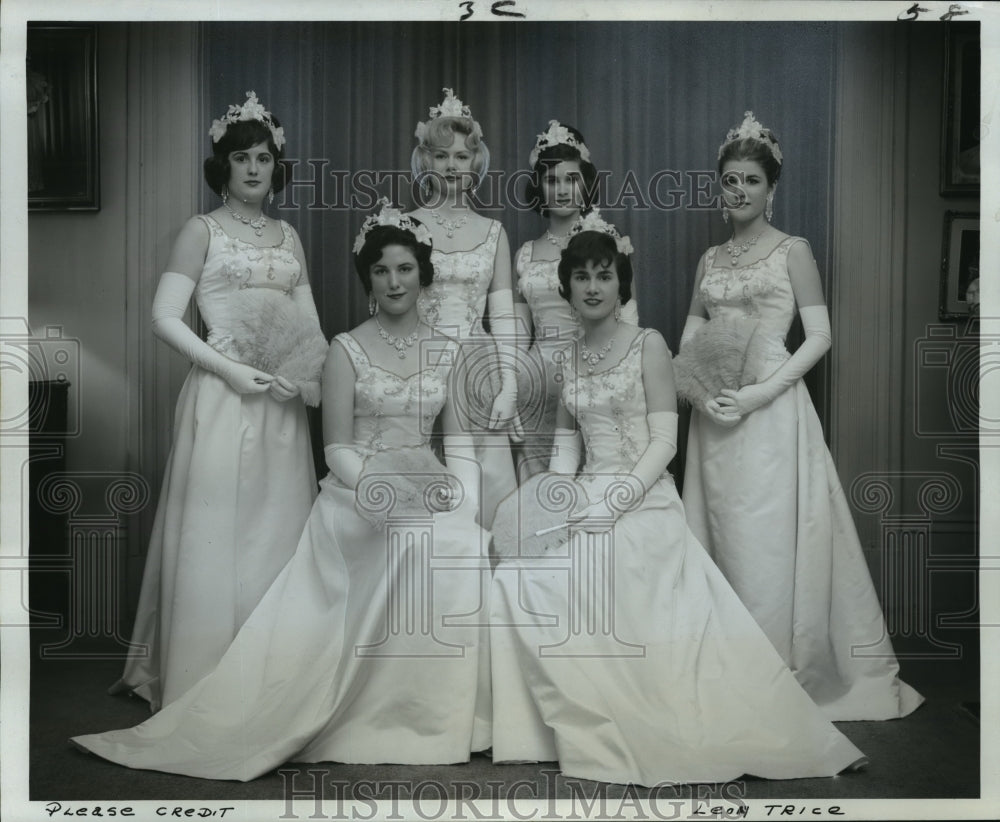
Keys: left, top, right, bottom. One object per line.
{"left": 153, "top": 271, "right": 273, "bottom": 394}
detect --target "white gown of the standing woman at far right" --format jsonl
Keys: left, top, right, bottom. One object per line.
{"left": 684, "top": 237, "right": 923, "bottom": 720}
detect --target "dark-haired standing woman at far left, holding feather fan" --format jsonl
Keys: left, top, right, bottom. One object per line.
{"left": 111, "top": 92, "right": 326, "bottom": 711}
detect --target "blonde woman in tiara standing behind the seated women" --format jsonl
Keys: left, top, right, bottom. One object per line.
{"left": 410, "top": 88, "right": 520, "bottom": 528}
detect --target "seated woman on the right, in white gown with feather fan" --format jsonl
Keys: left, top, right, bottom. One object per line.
{"left": 491, "top": 213, "right": 865, "bottom": 785}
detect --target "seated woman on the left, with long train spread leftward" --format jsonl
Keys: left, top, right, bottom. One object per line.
{"left": 73, "top": 203, "right": 489, "bottom": 781}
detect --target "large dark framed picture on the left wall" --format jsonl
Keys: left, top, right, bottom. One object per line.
{"left": 26, "top": 23, "right": 101, "bottom": 211}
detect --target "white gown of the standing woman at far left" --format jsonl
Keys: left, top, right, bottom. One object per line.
{"left": 111, "top": 216, "right": 316, "bottom": 710}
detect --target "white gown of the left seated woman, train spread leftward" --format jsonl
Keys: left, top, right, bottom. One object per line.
{"left": 73, "top": 334, "right": 490, "bottom": 781}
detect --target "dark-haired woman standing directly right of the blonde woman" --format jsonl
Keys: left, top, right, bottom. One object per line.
{"left": 514, "top": 120, "right": 639, "bottom": 482}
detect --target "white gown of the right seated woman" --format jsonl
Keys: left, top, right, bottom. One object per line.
{"left": 491, "top": 330, "right": 863, "bottom": 785}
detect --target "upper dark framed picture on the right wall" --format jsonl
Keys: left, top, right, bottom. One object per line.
{"left": 941, "top": 23, "right": 981, "bottom": 196}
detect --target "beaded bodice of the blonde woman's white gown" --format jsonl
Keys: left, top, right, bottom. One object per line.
{"left": 417, "top": 220, "right": 500, "bottom": 338}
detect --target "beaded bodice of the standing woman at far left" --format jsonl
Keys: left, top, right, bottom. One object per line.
{"left": 195, "top": 214, "right": 302, "bottom": 347}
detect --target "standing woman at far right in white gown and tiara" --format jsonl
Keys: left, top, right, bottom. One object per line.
{"left": 677, "top": 112, "right": 923, "bottom": 720}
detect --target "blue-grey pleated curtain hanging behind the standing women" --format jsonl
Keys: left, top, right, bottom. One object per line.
{"left": 204, "top": 22, "right": 836, "bottom": 349}
